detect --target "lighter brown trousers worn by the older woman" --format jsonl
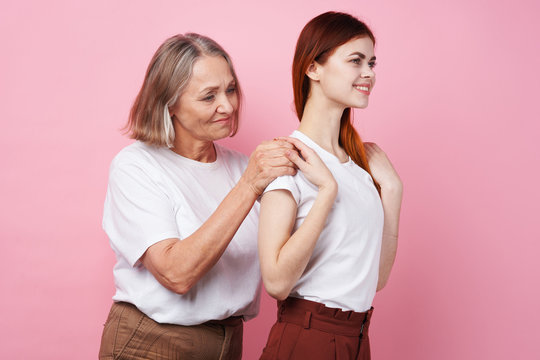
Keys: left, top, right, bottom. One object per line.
{"left": 99, "top": 302, "right": 244, "bottom": 360}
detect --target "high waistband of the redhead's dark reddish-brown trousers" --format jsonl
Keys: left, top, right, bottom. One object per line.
{"left": 278, "top": 297, "right": 373, "bottom": 336}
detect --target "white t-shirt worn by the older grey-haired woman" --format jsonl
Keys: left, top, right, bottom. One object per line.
{"left": 103, "top": 142, "right": 261, "bottom": 325}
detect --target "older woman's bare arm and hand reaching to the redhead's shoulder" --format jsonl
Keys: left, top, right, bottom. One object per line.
{"left": 141, "top": 141, "right": 296, "bottom": 294}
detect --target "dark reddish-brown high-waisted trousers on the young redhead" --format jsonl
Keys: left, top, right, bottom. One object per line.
{"left": 260, "top": 297, "right": 373, "bottom": 360}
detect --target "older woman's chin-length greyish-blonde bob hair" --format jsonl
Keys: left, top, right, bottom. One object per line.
{"left": 125, "top": 33, "right": 242, "bottom": 148}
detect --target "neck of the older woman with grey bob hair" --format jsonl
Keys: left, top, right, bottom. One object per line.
{"left": 171, "top": 122, "right": 217, "bottom": 163}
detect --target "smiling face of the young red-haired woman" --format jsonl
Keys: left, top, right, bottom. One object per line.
{"left": 317, "top": 36, "right": 375, "bottom": 109}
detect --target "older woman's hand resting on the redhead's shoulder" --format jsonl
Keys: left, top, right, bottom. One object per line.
{"left": 240, "top": 139, "right": 298, "bottom": 196}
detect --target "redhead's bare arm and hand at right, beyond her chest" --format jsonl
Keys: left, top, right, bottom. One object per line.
{"left": 365, "top": 143, "right": 403, "bottom": 291}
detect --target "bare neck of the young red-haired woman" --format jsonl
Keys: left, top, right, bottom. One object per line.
{"left": 298, "top": 92, "right": 348, "bottom": 161}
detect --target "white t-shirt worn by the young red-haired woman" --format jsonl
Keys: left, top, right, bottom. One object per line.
{"left": 265, "top": 130, "right": 384, "bottom": 312}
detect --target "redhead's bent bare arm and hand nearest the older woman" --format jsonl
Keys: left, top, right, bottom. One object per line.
{"left": 259, "top": 139, "right": 337, "bottom": 300}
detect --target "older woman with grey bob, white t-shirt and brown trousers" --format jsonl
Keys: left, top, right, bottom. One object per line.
{"left": 99, "top": 34, "right": 296, "bottom": 359}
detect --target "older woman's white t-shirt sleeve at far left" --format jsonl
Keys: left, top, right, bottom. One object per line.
{"left": 103, "top": 162, "right": 180, "bottom": 266}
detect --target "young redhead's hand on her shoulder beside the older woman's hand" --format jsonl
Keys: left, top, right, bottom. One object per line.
{"left": 280, "top": 137, "right": 337, "bottom": 190}
